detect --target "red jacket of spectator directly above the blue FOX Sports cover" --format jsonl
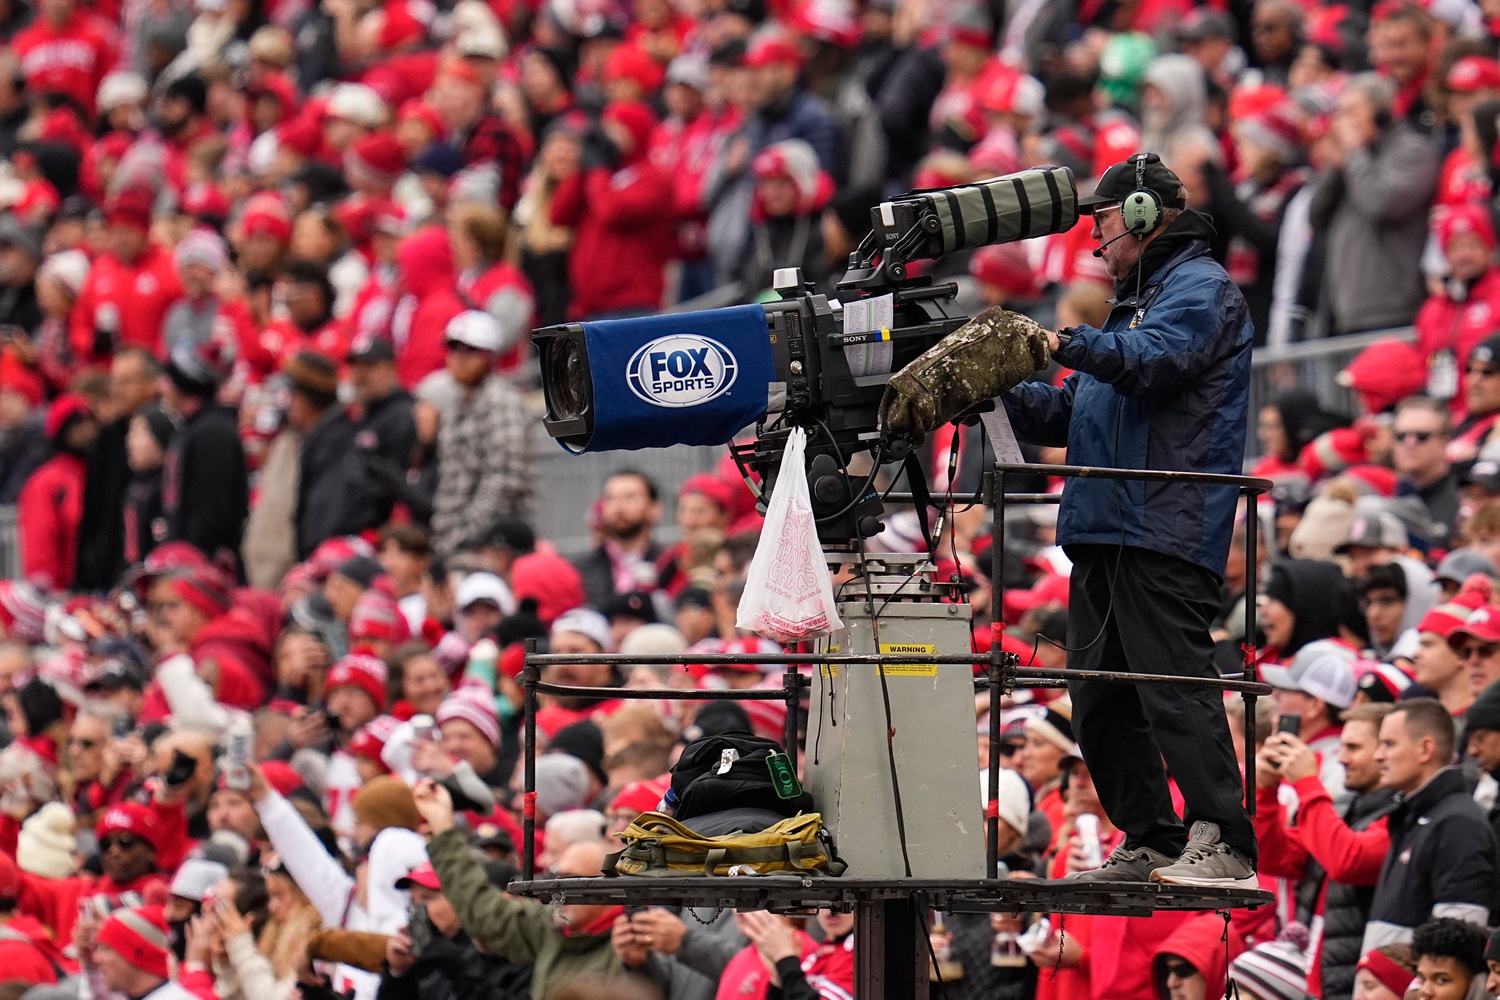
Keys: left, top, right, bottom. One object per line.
{"left": 552, "top": 157, "right": 672, "bottom": 318}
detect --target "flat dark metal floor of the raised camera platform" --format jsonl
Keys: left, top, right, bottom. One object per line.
{"left": 509, "top": 876, "right": 1275, "bottom": 916}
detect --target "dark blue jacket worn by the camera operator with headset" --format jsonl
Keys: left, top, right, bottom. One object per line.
{"left": 1004, "top": 240, "right": 1253, "bottom": 576}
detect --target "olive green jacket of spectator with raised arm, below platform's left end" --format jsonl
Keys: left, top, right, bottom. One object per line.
{"left": 428, "top": 829, "right": 621, "bottom": 1000}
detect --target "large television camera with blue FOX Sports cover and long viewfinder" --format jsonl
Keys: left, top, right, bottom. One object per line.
{"left": 533, "top": 166, "right": 1079, "bottom": 547}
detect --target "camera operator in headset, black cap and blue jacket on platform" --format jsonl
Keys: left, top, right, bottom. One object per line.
{"left": 1005, "top": 153, "right": 1257, "bottom": 889}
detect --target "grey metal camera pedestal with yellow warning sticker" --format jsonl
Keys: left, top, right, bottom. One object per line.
{"left": 804, "top": 552, "right": 984, "bottom": 879}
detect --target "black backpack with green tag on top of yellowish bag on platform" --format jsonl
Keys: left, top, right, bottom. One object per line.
{"left": 672, "top": 732, "right": 816, "bottom": 822}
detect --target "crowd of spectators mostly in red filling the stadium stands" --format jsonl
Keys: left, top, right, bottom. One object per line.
{"left": 11, "top": 0, "right": 1500, "bottom": 1000}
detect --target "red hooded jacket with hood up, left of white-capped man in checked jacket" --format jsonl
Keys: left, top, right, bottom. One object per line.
{"left": 392, "top": 226, "right": 464, "bottom": 388}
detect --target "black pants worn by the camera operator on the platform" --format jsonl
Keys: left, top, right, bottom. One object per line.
{"left": 1067, "top": 546, "right": 1256, "bottom": 861}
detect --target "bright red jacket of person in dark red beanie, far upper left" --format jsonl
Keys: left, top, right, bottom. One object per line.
{"left": 69, "top": 244, "right": 183, "bottom": 360}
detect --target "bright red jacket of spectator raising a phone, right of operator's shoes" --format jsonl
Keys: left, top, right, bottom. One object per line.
{"left": 1256, "top": 774, "right": 1391, "bottom": 997}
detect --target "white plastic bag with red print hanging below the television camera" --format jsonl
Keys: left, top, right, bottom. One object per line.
{"left": 735, "top": 427, "right": 843, "bottom": 643}
